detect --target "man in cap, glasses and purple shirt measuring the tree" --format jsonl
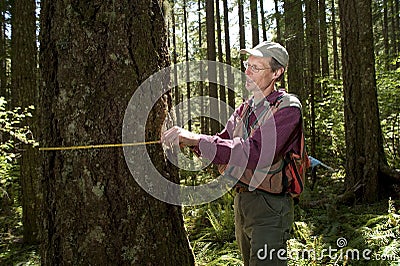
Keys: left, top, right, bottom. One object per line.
{"left": 162, "top": 42, "right": 302, "bottom": 266}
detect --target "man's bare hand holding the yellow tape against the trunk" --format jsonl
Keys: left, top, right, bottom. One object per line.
{"left": 161, "top": 126, "right": 200, "bottom": 147}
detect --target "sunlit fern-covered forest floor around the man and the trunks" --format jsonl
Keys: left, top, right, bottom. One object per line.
{"left": 0, "top": 167, "right": 400, "bottom": 266}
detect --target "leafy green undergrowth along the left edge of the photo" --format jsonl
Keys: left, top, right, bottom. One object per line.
{"left": 0, "top": 97, "right": 40, "bottom": 265}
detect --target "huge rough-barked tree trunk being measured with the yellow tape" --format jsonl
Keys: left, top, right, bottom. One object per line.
{"left": 40, "top": 0, "right": 194, "bottom": 265}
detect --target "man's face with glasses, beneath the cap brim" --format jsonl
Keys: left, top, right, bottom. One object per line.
{"left": 245, "top": 55, "right": 274, "bottom": 93}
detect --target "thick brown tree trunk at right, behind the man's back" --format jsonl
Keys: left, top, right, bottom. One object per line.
{"left": 339, "top": 0, "right": 386, "bottom": 202}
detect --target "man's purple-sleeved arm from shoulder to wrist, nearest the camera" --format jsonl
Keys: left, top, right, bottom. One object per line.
{"left": 198, "top": 107, "right": 301, "bottom": 169}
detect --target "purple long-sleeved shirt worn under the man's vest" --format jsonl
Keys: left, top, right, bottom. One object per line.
{"left": 195, "top": 90, "right": 302, "bottom": 169}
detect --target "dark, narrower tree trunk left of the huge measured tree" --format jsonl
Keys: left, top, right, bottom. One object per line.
{"left": 11, "top": 0, "right": 41, "bottom": 243}
